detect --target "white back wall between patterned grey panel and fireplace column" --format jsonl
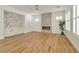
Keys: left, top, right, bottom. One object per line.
{"left": 24, "top": 14, "right": 41, "bottom": 33}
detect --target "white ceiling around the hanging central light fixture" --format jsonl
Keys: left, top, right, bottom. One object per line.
{"left": 9, "top": 5, "right": 71, "bottom": 13}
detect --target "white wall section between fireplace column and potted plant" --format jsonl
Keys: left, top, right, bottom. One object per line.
{"left": 52, "top": 11, "right": 64, "bottom": 34}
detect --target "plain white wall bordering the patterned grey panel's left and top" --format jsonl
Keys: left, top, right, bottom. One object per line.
{"left": 0, "top": 5, "right": 25, "bottom": 39}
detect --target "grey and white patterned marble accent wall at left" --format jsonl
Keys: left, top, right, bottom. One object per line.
{"left": 4, "top": 11, "right": 24, "bottom": 36}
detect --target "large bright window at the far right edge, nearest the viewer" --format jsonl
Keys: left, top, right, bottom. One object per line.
{"left": 73, "top": 5, "right": 79, "bottom": 35}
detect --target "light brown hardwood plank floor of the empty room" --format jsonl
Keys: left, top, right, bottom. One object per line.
{"left": 0, "top": 32, "right": 77, "bottom": 53}
